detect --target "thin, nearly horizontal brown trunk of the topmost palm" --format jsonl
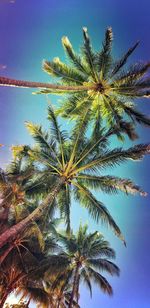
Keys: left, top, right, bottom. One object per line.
{"left": 0, "top": 76, "right": 91, "bottom": 92}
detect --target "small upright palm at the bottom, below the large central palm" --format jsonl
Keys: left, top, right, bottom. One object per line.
{"left": 53, "top": 225, "right": 120, "bottom": 308}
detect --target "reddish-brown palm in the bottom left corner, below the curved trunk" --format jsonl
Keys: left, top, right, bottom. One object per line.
{"left": 0, "top": 215, "right": 45, "bottom": 307}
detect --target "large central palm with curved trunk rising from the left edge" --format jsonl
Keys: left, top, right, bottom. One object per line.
{"left": 0, "top": 107, "right": 150, "bottom": 247}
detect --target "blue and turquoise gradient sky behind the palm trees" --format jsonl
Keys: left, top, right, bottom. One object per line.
{"left": 0, "top": 0, "right": 150, "bottom": 308}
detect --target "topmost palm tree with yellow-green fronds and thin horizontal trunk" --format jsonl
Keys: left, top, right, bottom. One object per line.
{"left": 0, "top": 28, "right": 150, "bottom": 139}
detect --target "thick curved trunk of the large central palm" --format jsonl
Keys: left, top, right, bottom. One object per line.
{"left": 0, "top": 177, "right": 65, "bottom": 248}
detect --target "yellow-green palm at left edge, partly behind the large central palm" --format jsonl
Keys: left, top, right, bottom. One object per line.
{"left": 0, "top": 150, "right": 59, "bottom": 250}
